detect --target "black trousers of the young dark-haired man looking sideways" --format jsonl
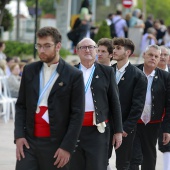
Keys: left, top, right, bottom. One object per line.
{"left": 115, "top": 129, "right": 136, "bottom": 170}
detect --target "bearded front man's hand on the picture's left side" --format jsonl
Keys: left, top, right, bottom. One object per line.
{"left": 16, "top": 138, "right": 30, "bottom": 161}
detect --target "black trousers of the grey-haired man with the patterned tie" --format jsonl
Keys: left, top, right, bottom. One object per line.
{"left": 129, "top": 123, "right": 160, "bottom": 170}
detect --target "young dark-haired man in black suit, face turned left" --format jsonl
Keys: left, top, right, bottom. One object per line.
{"left": 112, "top": 38, "right": 147, "bottom": 170}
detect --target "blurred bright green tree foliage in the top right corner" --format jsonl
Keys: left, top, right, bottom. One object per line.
{"left": 138, "top": 0, "right": 170, "bottom": 25}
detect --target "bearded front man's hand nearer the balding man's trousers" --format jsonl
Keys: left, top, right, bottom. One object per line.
{"left": 54, "top": 148, "right": 70, "bottom": 168}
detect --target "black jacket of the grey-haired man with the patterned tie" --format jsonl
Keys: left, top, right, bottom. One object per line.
{"left": 137, "top": 64, "right": 170, "bottom": 133}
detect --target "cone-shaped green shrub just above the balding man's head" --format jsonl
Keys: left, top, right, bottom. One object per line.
{"left": 94, "top": 21, "right": 111, "bottom": 43}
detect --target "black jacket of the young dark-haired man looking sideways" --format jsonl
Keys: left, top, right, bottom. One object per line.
{"left": 112, "top": 63, "right": 147, "bottom": 134}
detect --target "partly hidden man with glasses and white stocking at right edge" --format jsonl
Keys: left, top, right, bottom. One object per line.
{"left": 158, "top": 46, "right": 170, "bottom": 169}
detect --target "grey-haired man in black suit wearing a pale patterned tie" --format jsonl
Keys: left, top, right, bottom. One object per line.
{"left": 129, "top": 45, "right": 170, "bottom": 170}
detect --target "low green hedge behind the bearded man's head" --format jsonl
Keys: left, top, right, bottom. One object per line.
{"left": 4, "top": 41, "right": 71, "bottom": 59}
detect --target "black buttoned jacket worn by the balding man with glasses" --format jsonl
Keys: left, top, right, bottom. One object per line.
{"left": 76, "top": 63, "right": 122, "bottom": 133}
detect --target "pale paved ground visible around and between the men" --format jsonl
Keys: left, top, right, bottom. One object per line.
{"left": 0, "top": 56, "right": 163, "bottom": 170}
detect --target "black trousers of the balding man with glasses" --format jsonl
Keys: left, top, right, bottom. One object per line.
{"left": 70, "top": 123, "right": 110, "bottom": 170}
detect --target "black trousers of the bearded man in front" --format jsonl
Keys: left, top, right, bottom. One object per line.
{"left": 16, "top": 137, "right": 69, "bottom": 170}
